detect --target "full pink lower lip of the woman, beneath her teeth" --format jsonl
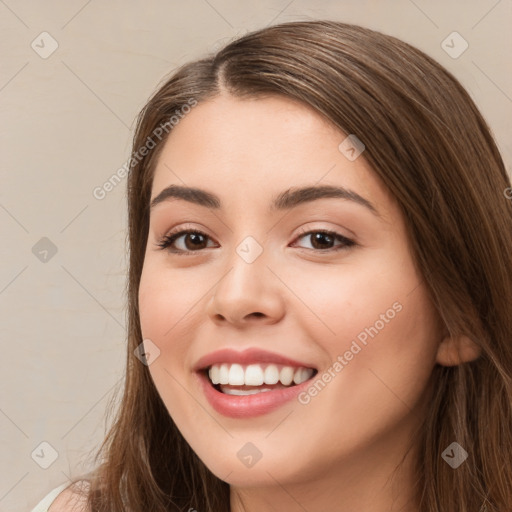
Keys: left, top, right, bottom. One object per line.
{"left": 196, "top": 373, "right": 311, "bottom": 418}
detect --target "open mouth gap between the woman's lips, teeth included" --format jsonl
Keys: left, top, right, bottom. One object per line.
{"left": 204, "top": 363, "right": 317, "bottom": 396}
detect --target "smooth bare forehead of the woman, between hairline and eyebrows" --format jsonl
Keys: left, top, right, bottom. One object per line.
{"left": 152, "top": 95, "right": 389, "bottom": 216}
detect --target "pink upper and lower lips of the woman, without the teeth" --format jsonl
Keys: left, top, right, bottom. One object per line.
{"left": 194, "top": 348, "right": 312, "bottom": 418}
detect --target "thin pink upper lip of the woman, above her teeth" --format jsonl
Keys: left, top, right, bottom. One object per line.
{"left": 194, "top": 348, "right": 314, "bottom": 371}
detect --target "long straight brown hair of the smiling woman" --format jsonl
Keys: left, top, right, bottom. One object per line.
{"left": 72, "top": 21, "right": 512, "bottom": 512}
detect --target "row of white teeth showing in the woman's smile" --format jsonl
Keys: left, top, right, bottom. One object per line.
{"left": 208, "top": 363, "right": 314, "bottom": 386}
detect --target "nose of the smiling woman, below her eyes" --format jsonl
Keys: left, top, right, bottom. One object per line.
{"left": 207, "top": 246, "right": 285, "bottom": 327}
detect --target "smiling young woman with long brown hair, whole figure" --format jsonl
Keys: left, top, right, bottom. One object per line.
{"left": 34, "top": 21, "right": 512, "bottom": 512}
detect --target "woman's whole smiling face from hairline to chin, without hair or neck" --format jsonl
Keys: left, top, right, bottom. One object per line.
{"left": 139, "top": 95, "right": 440, "bottom": 487}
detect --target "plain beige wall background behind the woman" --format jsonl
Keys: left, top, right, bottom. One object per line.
{"left": 0, "top": 0, "right": 512, "bottom": 512}
